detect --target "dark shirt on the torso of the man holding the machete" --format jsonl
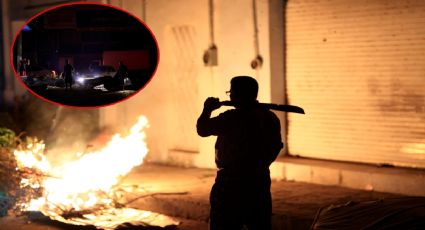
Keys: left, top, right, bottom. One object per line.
{"left": 197, "top": 106, "right": 282, "bottom": 174}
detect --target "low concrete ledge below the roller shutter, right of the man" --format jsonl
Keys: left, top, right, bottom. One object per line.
{"left": 271, "top": 157, "right": 425, "bottom": 196}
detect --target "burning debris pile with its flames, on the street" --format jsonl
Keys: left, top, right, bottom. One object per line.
{"left": 0, "top": 116, "right": 178, "bottom": 229}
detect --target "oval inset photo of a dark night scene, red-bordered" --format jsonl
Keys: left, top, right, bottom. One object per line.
{"left": 11, "top": 3, "right": 159, "bottom": 107}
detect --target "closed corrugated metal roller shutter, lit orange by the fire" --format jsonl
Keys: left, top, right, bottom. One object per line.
{"left": 285, "top": 0, "right": 425, "bottom": 168}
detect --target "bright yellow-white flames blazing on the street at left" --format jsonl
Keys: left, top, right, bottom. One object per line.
{"left": 14, "top": 116, "right": 177, "bottom": 228}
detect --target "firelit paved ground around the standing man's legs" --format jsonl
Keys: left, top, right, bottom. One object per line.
{"left": 0, "top": 165, "right": 399, "bottom": 230}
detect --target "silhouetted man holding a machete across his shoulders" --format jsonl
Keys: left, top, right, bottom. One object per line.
{"left": 197, "top": 76, "right": 283, "bottom": 230}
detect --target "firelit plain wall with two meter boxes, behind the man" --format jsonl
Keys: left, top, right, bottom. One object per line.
{"left": 101, "top": 0, "right": 285, "bottom": 167}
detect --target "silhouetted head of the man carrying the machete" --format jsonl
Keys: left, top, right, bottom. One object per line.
{"left": 230, "top": 76, "right": 258, "bottom": 105}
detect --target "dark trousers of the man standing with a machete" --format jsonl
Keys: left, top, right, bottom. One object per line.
{"left": 210, "top": 170, "right": 272, "bottom": 230}
